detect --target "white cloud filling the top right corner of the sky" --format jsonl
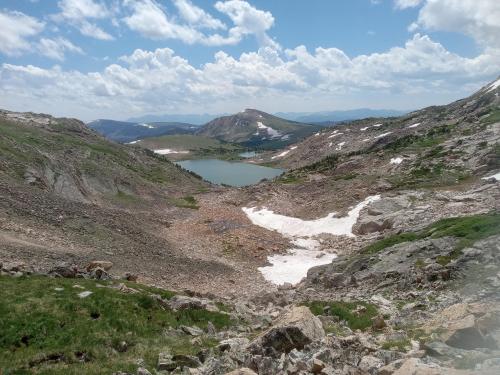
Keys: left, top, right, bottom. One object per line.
{"left": 412, "top": 0, "right": 500, "bottom": 48}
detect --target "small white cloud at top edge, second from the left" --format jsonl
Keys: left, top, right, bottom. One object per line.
{"left": 51, "top": 0, "right": 114, "bottom": 40}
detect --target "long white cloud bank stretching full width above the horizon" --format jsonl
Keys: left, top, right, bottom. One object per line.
{"left": 0, "top": 34, "right": 500, "bottom": 119}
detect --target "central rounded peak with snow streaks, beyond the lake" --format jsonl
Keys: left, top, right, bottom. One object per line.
{"left": 196, "top": 109, "right": 321, "bottom": 149}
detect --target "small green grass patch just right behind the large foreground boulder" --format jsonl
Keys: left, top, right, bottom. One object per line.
{"left": 304, "top": 301, "right": 378, "bottom": 330}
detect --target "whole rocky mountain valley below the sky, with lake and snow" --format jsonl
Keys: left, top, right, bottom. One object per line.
{"left": 0, "top": 81, "right": 500, "bottom": 375}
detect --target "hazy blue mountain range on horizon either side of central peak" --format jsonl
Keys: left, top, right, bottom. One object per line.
{"left": 127, "top": 108, "right": 410, "bottom": 125}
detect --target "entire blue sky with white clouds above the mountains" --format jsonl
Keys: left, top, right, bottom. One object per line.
{"left": 0, "top": 0, "right": 500, "bottom": 121}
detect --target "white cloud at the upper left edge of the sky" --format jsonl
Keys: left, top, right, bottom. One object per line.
{"left": 0, "top": 10, "right": 44, "bottom": 56}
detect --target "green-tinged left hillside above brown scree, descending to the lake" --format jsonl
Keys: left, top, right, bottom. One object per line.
{"left": 0, "top": 118, "right": 202, "bottom": 198}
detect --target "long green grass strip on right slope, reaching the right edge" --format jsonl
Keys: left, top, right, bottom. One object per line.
{"left": 363, "top": 211, "right": 500, "bottom": 258}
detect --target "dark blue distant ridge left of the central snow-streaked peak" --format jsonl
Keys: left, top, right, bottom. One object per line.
{"left": 87, "top": 120, "right": 198, "bottom": 143}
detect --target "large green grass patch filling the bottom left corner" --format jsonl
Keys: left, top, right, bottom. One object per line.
{"left": 0, "top": 276, "right": 233, "bottom": 375}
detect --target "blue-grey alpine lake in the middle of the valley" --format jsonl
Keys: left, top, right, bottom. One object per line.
{"left": 177, "top": 159, "right": 283, "bottom": 186}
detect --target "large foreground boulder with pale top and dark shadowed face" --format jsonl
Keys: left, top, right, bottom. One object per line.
{"left": 249, "top": 306, "right": 325, "bottom": 357}
